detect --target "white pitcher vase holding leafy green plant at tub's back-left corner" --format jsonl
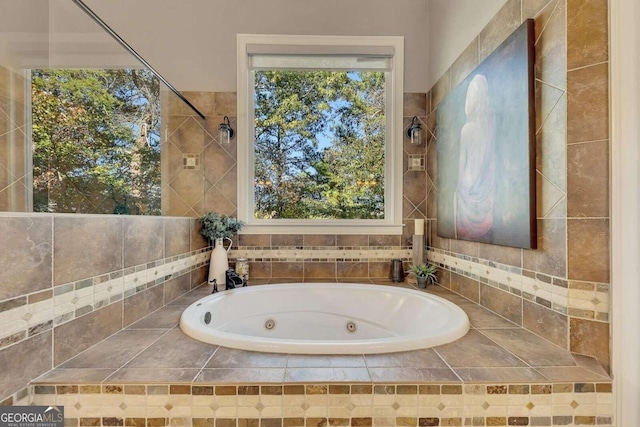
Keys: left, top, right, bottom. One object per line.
{"left": 198, "top": 212, "right": 244, "bottom": 286}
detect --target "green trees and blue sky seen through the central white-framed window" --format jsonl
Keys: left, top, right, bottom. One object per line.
{"left": 254, "top": 70, "right": 386, "bottom": 219}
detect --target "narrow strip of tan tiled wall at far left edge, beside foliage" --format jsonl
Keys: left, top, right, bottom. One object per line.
{"left": 0, "top": 66, "right": 28, "bottom": 212}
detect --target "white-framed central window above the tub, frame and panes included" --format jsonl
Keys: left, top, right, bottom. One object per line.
{"left": 238, "top": 35, "right": 403, "bottom": 234}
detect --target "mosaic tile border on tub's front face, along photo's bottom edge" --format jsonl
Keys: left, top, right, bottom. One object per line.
{"left": 31, "top": 383, "right": 613, "bottom": 427}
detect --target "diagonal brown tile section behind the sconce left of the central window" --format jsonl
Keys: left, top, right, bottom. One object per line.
{"left": 162, "top": 92, "right": 237, "bottom": 217}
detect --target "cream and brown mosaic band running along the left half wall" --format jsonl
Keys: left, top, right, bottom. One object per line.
{"left": 0, "top": 249, "right": 210, "bottom": 349}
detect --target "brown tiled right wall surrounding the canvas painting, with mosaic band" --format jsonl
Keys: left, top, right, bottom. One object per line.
{"left": 427, "top": 0, "right": 610, "bottom": 367}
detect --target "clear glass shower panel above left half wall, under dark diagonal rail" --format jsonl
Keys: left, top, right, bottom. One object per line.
{"left": 0, "top": 0, "right": 204, "bottom": 216}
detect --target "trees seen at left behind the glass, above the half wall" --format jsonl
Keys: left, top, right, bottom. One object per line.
{"left": 31, "top": 69, "right": 160, "bottom": 215}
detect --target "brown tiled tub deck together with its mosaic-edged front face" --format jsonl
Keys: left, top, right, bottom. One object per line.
{"left": 26, "top": 283, "right": 613, "bottom": 427}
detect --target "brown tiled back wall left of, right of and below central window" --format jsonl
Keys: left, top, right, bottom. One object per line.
{"left": 162, "top": 92, "right": 427, "bottom": 279}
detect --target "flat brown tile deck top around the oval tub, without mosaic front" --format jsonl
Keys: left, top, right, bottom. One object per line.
{"left": 34, "top": 279, "right": 610, "bottom": 384}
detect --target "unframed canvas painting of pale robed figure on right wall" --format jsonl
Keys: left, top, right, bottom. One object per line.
{"left": 437, "top": 20, "right": 537, "bottom": 248}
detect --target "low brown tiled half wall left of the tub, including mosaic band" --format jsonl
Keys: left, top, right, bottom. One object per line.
{"left": 0, "top": 214, "right": 208, "bottom": 406}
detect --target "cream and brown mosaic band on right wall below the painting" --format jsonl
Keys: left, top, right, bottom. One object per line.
{"left": 427, "top": 248, "right": 610, "bottom": 322}
